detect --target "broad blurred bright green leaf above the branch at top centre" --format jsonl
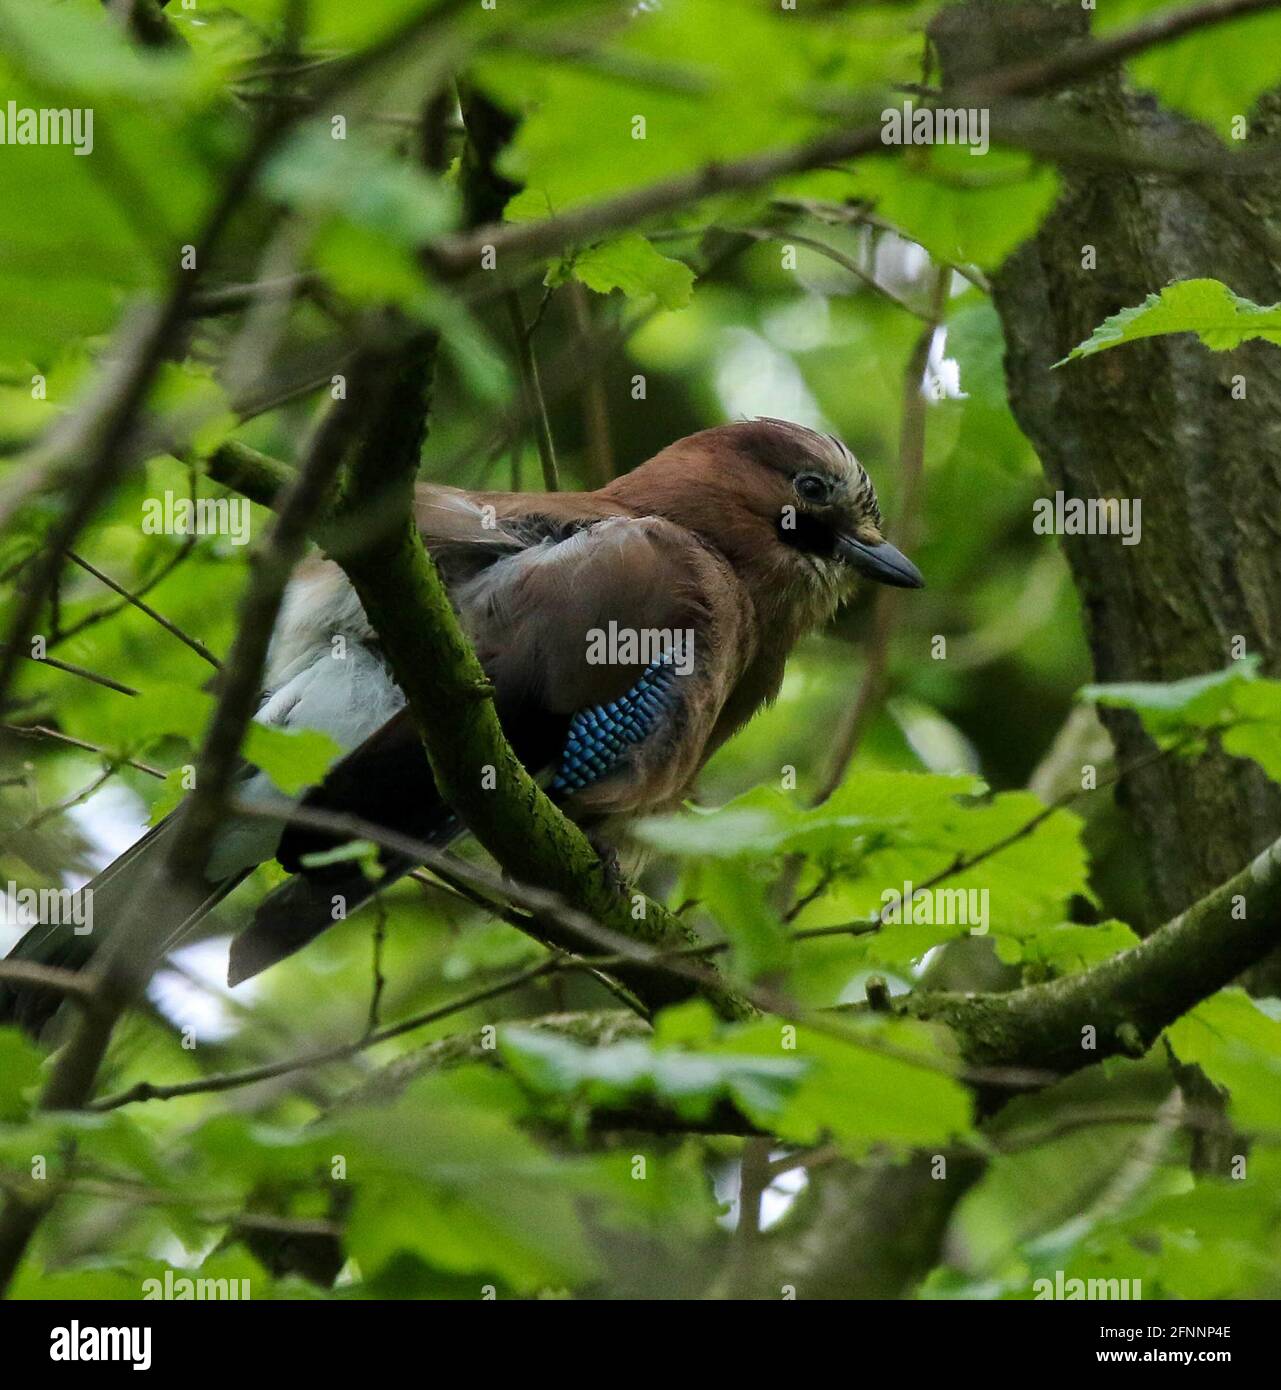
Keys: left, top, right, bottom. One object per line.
{"left": 472, "top": 0, "right": 920, "bottom": 220}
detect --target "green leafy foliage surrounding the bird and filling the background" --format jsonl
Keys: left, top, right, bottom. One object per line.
{"left": 0, "top": 0, "right": 1281, "bottom": 1300}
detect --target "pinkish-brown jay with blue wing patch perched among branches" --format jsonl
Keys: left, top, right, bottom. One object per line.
{"left": 0, "top": 417, "right": 924, "bottom": 1029}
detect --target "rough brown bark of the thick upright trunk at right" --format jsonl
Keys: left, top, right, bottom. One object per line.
{"left": 932, "top": 3, "right": 1281, "bottom": 927}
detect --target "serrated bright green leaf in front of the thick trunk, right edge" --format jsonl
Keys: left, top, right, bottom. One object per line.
{"left": 1055, "top": 279, "right": 1281, "bottom": 367}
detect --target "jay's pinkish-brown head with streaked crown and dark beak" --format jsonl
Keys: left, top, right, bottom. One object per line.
{"left": 609, "top": 420, "right": 925, "bottom": 621}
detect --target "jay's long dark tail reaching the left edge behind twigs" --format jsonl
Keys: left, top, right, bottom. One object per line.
{"left": 0, "top": 816, "right": 249, "bottom": 1034}
